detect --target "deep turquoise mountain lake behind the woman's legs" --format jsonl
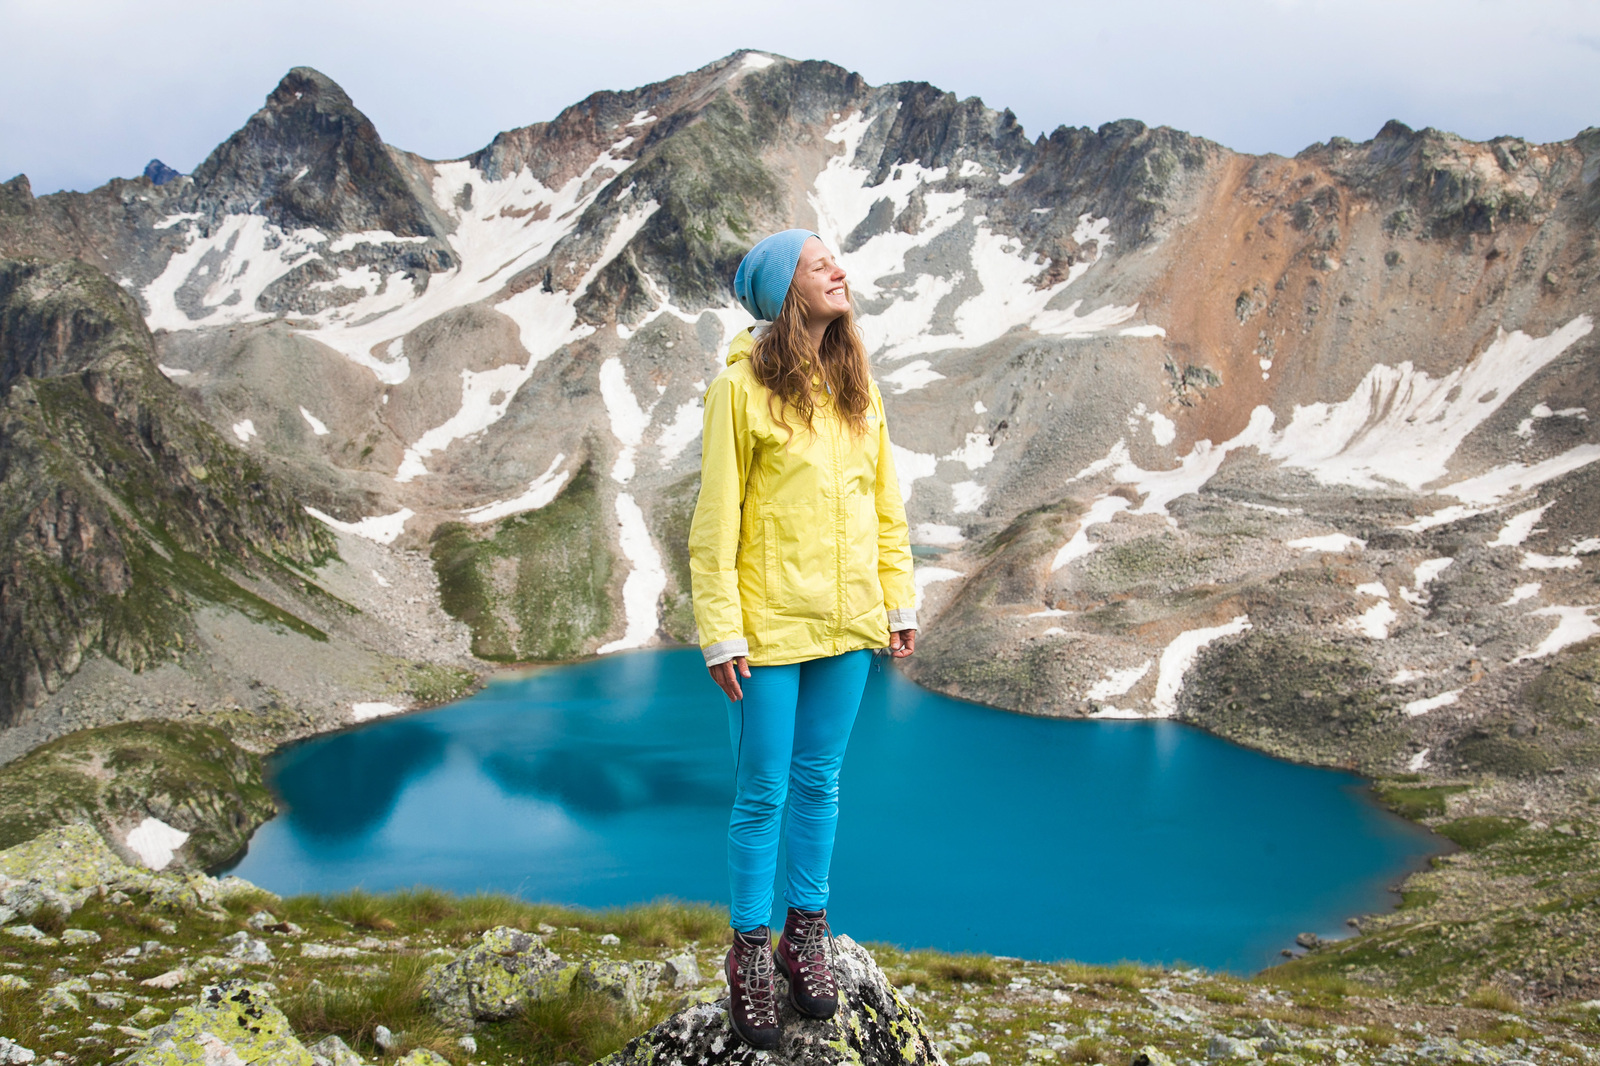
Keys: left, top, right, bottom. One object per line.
{"left": 234, "top": 648, "right": 1440, "bottom": 972}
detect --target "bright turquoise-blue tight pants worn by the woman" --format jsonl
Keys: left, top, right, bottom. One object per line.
{"left": 728, "top": 650, "right": 872, "bottom": 933}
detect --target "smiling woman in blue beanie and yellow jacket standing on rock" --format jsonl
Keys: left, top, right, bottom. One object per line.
{"left": 690, "top": 229, "right": 917, "bottom": 1048}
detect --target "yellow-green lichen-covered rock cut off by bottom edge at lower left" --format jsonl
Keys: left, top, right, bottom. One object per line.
{"left": 125, "top": 981, "right": 315, "bottom": 1066}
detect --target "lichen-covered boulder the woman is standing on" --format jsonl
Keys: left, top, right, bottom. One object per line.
{"left": 602, "top": 936, "right": 944, "bottom": 1066}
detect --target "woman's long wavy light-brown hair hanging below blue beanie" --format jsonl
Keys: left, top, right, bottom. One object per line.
{"left": 750, "top": 287, "right": 872, "bottom": 437}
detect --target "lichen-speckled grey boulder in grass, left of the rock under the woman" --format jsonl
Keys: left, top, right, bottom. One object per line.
{"left": 422, "top": 925, "right": 578, "bottom": 1028}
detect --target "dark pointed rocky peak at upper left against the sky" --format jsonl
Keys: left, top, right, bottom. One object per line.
{"left": 194, "top": 67, "right": 445, "bottom": 237}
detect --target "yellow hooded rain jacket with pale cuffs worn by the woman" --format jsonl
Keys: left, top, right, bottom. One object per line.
{"left": 690, "top": 330, "right": 917, "bottom": 666}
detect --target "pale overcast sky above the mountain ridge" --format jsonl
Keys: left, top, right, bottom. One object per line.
{"left": 9, "top": 0, "right": 1600, "bottom": 194}
